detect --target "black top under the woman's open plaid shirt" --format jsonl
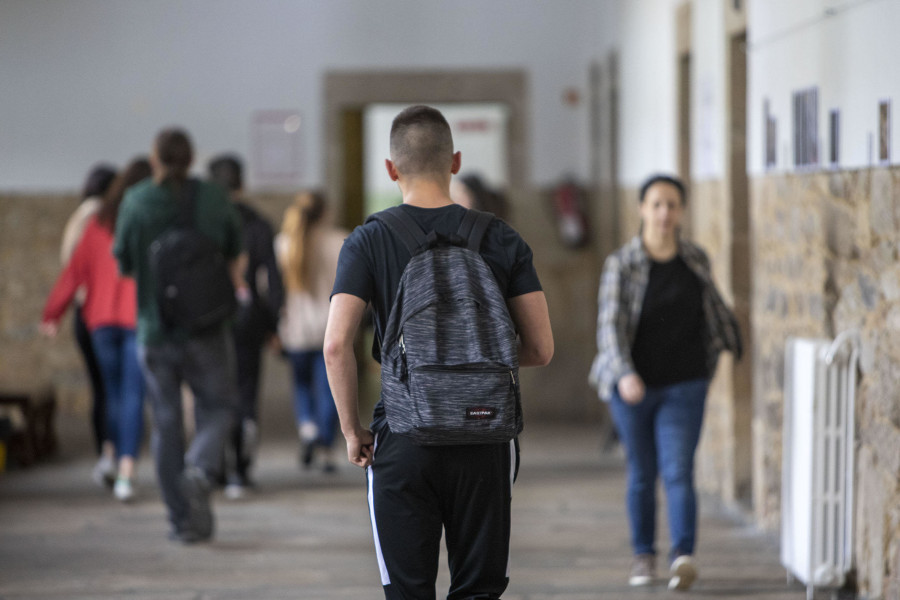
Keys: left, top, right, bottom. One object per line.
{"left": 631, "top": 257, "right": 709, "bottom": 386}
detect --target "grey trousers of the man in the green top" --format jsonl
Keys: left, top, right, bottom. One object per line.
{"left": 139, "top": 328, "right": 238, "bottom": 530}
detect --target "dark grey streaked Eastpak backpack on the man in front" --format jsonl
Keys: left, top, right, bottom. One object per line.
{"left": 368, "top": 207, "right": 522, "bottom": 445}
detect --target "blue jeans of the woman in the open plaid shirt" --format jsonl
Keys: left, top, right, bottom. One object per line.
{"left": 610, "top": 379, "right": 709, "bottom": 557}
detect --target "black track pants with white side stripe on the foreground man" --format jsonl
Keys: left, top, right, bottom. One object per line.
{"left": 368, "top": 427, "right": 518, "bottom": 600}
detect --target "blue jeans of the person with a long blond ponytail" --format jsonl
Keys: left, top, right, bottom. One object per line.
{"left": 287, "top": 350, "right": 337, "bottom": 448}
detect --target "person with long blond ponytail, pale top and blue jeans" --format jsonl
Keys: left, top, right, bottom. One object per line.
{"left": 275, "top": 192, "right": 347, "bottom": 472}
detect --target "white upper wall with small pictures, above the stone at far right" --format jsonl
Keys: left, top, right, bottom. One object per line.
{"left": 747, "top": 0, "right": 900, "bottom": 175}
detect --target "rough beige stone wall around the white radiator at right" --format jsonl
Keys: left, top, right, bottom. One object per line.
{"left": 751, "top": 169, "right": 900, "bottom": 598}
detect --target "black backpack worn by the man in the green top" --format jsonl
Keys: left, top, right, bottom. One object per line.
{"left": 148, "top": 180, "right": 237, "bottom": 334}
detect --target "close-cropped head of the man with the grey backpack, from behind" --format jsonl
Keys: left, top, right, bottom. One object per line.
{"left": 391, "top": 105, "right": 453, "bottom": 176}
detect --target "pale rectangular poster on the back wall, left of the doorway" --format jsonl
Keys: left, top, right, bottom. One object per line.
{"left": 250, "top": 110, "right": 302, "bottom": 188}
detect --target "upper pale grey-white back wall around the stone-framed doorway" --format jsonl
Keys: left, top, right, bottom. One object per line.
{"left": 0, "top": 0, "right": 619, "bottom": 191}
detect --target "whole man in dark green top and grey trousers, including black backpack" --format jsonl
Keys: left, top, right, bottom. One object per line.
{"left": 113, "top": 129, "right": 249, "bottom": 543}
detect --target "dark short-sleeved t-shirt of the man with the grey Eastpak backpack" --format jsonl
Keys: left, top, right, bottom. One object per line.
{"left": 331, "top": 204, "right": 541, "bottom": 431}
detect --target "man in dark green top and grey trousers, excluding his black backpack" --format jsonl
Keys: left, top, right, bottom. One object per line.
{"left": 113, "top": 128, "right": 248, "bottom": 544}
